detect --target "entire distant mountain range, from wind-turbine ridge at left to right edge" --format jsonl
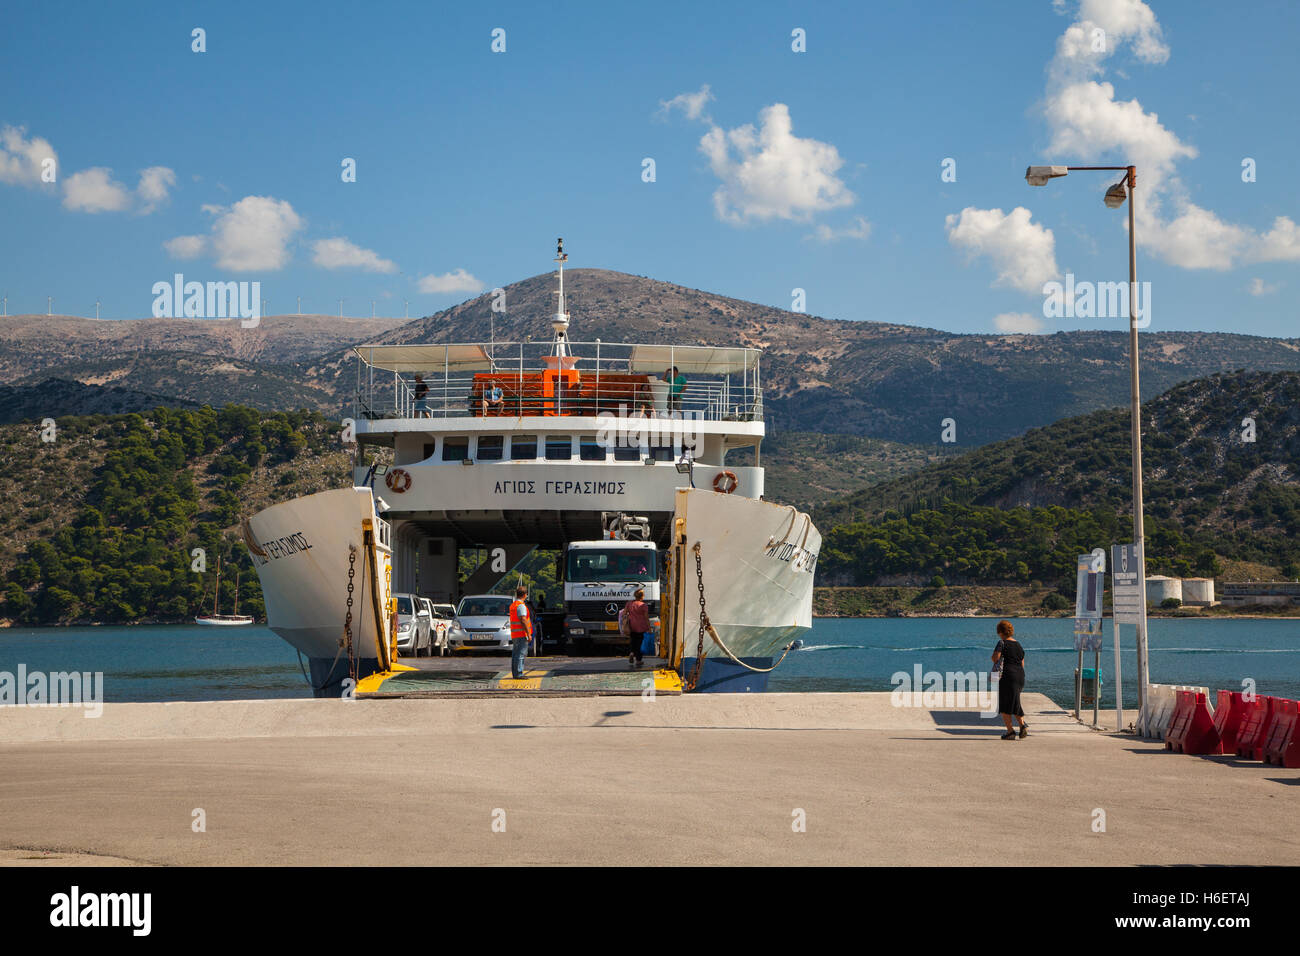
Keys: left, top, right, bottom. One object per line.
{"left": 0, "top": 269, "right": 1300, "bottom": 454}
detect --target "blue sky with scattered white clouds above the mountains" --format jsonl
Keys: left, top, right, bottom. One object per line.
{"left": 0, "top": 0, "right": 1300, "bottom": 336}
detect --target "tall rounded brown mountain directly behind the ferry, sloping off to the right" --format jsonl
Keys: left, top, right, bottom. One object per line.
{"left": 304, "top": 269, "right": 1300, "bottom": 447}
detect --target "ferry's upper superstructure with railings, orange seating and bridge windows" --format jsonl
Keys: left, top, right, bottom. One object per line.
{"left": 354, "top": 339, "right": 764, "bottom": 546}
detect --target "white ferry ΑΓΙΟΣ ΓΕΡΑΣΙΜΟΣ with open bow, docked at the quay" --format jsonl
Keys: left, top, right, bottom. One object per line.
{"left": 242, "top": 239, "right": 822, "bottom": 696}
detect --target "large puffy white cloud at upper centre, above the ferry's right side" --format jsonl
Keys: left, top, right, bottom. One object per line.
{"left": 699, "top": 103, "right": 855, "bottom": 224}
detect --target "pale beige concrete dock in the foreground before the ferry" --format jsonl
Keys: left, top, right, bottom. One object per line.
{"left": 0, "top": 693, "right": 1300, "bottom": 866}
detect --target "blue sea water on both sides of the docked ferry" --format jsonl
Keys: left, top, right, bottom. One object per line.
{"left": 0, "top": 618, "right": 1300, "bottom": 709}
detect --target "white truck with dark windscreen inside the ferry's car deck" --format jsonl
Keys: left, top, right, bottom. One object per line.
{"left": 563, "top": 514, "right": 660, "bottom": 650}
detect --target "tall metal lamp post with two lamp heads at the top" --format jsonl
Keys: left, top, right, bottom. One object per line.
{"left": 1024, "top": 166, "right": 1151, "bottom": 734}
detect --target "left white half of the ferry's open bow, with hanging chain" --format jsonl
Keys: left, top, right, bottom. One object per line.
{"left": 244, "top": 488, "right": 391, "bottom": 696}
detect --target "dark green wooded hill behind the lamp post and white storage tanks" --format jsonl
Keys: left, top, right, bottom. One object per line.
{"left": 816, "top": 372, "right": 1300, "bottom": 585}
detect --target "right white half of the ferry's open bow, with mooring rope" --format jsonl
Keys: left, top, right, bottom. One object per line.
{"left": 675, "top": 489, "right": 822, "bottom": 693}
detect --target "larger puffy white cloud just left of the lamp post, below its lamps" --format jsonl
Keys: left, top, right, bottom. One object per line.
{"left": 945, "top": 206, "right": 1061, "bottom": 295}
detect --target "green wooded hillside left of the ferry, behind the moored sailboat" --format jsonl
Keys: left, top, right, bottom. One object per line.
{"left": 0, "top": 406, "right": 351, "bottom": 624}
